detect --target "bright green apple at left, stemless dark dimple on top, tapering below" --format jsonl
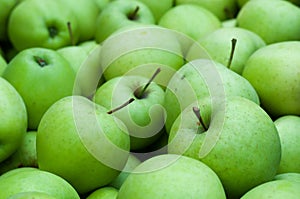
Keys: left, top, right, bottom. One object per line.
{"left": 3, "top": 47, "right": 75, "bottom": 130}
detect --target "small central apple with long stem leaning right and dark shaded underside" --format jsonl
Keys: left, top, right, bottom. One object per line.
{"left": 94, "top": 74, "right": 165, "bottom": 150}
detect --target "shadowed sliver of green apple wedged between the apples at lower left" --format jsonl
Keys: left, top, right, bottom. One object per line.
{"left": 0, "top": 131, "right": 38, "bottom": 174}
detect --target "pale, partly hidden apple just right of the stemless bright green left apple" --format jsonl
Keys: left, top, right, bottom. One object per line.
{"left": 57, "top": 43, "right": 102, "bottom": 97}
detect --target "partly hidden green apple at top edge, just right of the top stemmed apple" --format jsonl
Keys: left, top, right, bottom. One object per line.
{"left": 138, "top": 0, "right": 174, "bottom": 22}
